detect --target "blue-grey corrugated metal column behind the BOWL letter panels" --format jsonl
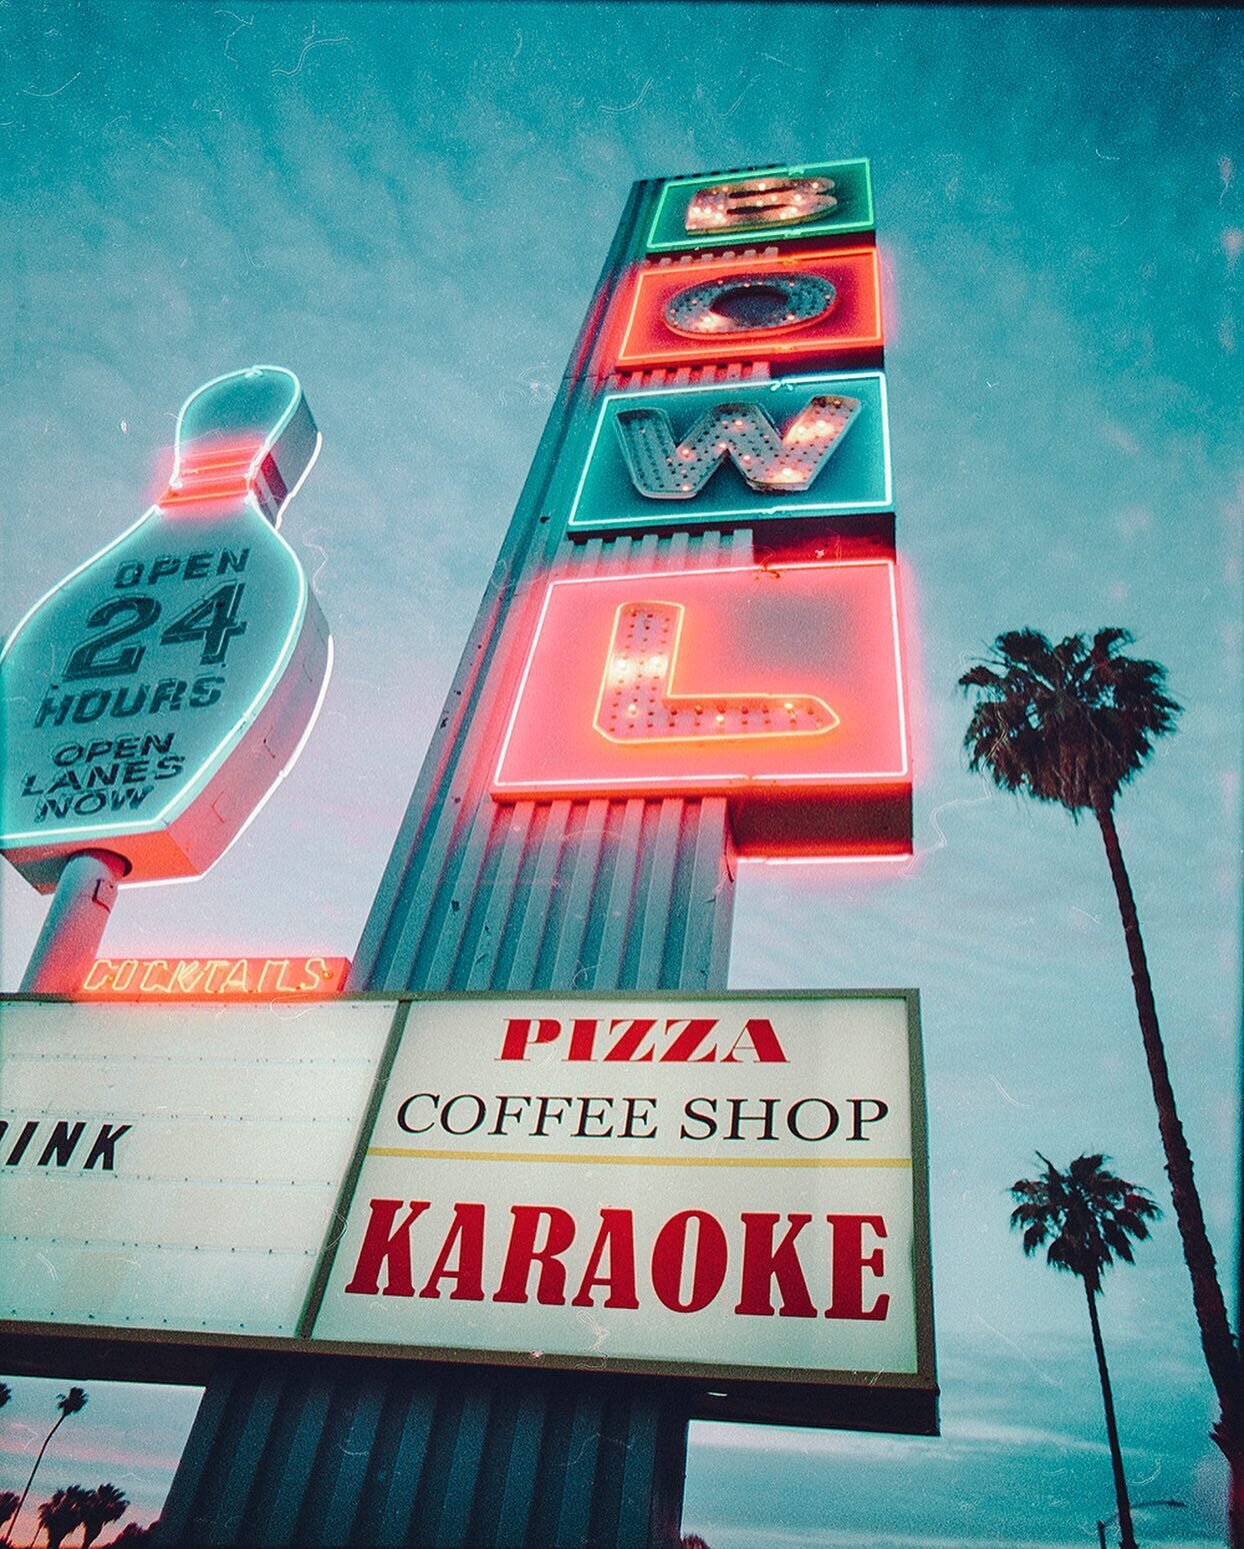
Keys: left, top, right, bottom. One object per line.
{"left": 161, "top": 175, "right": 734, "bottom": 1549}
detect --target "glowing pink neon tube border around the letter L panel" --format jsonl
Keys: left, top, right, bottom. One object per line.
{"left": 490, "top": 559, "right": 911, "bottom": 793}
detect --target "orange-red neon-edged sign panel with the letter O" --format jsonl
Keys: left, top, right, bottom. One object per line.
{"left": 618, "top": 246, "right": 881, "bottom": 366}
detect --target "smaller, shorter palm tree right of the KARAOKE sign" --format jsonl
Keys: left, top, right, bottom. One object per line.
{"left": 1010, "top": 1151, "right": 1162, "bottom": 1549}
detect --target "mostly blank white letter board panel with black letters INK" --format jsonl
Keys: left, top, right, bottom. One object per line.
{"left": 0, "top": 1001, "right": 395, "bottom": 1337}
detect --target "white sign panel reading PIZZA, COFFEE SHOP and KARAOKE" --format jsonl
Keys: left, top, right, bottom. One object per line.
{"left": 311, "top": 991, "right": 933, "bottom": 1389}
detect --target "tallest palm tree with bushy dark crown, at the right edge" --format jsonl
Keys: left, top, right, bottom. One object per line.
{"left": 959, "top": 629, "right": 1244, "bottom": 1549}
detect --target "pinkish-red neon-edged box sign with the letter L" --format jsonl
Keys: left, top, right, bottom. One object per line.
{"left": 493, "top": 559, "right": 911, "bottom": 855}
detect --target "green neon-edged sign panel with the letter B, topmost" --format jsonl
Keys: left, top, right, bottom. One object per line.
{"left": 648, "top": 156, "right": 874, "bottom": 252}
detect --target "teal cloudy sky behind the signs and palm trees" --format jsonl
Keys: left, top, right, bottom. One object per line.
{"left": 0, "top": 0, "right": 1244, "bottom": 1549}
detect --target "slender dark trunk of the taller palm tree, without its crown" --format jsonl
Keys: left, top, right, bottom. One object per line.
{"left": 1094, "top": 801, "right": 1244, "bottom": 1549}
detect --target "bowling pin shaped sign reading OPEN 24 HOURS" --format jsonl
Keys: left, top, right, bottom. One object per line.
{"left": 0, "top": 366, "right": 332, "bottom": 892}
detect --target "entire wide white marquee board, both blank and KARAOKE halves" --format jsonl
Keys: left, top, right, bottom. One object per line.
{"left": 0, "top": 991, "right": 936, "bottom": 1428}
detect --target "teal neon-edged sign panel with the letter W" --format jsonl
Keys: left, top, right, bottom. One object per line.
{"left": 569, "top": 372, "right": 892, "bottom": 534}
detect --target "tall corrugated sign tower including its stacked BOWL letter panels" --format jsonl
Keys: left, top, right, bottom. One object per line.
{"left": 151, "top": 161, "right": 936, "bottom": 1549}
